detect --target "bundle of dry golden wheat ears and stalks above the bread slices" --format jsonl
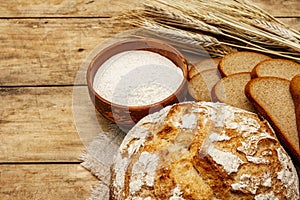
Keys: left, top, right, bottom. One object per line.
{"left": 120, "top": 0, "right": 300, "bottom": 62}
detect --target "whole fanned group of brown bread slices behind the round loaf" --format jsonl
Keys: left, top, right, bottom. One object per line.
{"left": 188, "top": 52, "right": 300, "bottom": 165}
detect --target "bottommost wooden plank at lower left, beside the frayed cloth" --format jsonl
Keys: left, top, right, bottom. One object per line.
{"left": 0, "top": 164, "right": 98, "bottom": 200}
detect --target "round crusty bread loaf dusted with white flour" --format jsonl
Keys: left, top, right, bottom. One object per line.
{"left": 110, "top": 102, "right": 300, "bottom": 200}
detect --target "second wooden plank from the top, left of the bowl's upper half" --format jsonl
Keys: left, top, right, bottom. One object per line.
{"left": 0, "top": 19, "right": 128, "bottom": 86}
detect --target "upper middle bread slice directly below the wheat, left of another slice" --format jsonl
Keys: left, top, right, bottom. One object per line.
{"left": 218, "top": 52, "right": 270, "bottom": 77}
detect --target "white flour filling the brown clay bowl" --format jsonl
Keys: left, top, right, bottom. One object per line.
{"left": 93, "top": 50, "right": 184, "bottom": 106}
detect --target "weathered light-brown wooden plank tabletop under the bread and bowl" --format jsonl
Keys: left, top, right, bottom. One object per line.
{"left": 0, "top": 0, "right": 300, "bottom": 199}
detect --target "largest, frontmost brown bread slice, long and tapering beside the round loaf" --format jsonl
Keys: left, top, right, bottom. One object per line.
{"left": 245, "top": 77, "right": 300, "bottom": 164}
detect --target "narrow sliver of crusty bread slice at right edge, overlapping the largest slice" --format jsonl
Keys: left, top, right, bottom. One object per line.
{"left": 290, "top": 74, "right": 300, "bottom": 145}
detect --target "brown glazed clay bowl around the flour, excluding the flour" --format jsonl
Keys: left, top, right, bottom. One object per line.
{"left": 86, "top": 39, "right": 188, "bottom": 129}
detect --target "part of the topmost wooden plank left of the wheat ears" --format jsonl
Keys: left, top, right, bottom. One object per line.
{"left": 0, "top": 0, "right": 140, "bottom": 18}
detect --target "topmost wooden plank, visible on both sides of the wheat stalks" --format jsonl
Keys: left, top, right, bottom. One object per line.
{"left": 0, "top": 0, "right": 300, "bottom": 18}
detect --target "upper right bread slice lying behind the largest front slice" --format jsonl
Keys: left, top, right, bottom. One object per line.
{"left": 251, "top": 59, "right": 300, "bottom": 80}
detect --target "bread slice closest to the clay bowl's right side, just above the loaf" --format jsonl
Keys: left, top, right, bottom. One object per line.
{"left": 188, "top": 68, "right": 221, "bottom": 101}
